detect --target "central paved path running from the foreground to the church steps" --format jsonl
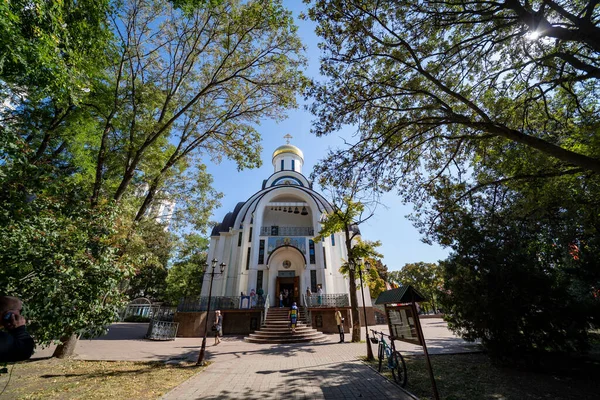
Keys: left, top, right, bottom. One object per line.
{"left": 163, "top": 339, "right": 412, "bottom": 400}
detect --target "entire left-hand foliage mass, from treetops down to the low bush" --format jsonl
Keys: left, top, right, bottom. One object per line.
{"left": 0, "top": 0, "right": 305, "bottom": 350}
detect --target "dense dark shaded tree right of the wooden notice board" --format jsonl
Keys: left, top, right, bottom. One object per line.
{"left": 436, "top": 177, "right": 600, "bottom": 357}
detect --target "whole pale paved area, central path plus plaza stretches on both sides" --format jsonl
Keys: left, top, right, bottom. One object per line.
{"left": 34, "top": 318, "right": 479, "bottom": 400}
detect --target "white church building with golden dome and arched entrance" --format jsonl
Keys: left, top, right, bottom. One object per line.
{"left": 175, "top": 136, "right": 372, "bottom": 334}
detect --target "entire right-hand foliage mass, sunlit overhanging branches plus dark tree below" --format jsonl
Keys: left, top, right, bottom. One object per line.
{"left": 307, "top": 0, "right": 600, "bottom": 360}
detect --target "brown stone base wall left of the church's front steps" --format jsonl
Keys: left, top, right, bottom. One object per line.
{"left": 173, "top": 310, "right": 260, "bottom": 337}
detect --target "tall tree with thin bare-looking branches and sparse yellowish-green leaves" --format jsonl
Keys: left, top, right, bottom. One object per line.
{"left": 90, "top": 0, "right": 304, "bottom": 212}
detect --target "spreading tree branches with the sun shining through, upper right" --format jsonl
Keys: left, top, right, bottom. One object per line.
{"left": 307, "top": 0, "right": 600, "bottom": 212}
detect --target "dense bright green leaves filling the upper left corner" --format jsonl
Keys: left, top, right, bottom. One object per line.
{"left": 0, "top": 0, "right": 112, "bottom": 104}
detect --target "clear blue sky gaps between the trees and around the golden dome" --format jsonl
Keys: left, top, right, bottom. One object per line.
{"left": 202, "top": 0, "right": 448, "bottom": 270}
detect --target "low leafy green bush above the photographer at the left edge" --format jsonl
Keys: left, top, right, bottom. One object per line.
{"left": 0, "top": 195, "right": 131, "bottom": 345}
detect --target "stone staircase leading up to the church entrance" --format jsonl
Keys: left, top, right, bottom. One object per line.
{"left": 244, "top": 307, "right": 327, "bottom": 343}
